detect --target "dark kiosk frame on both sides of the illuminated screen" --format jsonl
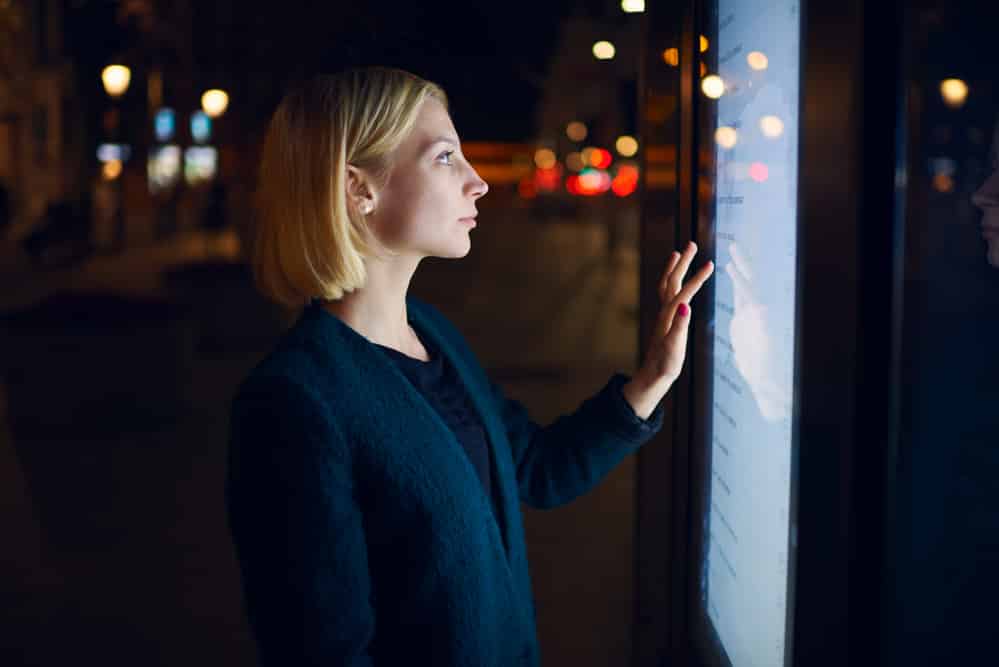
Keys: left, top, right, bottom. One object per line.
{"left": 634, "top": 0, "right": 906, "bottom": 667}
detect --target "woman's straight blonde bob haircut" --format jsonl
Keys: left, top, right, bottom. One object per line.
{"left": 250, "top": 67, "right": 448, "bottom": 308}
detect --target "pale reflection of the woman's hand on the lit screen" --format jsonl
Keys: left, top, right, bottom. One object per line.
{"left": 725, "top": 243, "right": 791, "bottom": 422}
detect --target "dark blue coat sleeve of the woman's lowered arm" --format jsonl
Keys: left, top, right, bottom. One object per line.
{"left": 226, "top": 378, "right": 374, "bottom": 667}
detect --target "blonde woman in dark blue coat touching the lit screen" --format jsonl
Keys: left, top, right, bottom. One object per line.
{"left": 227, "top": 68, "right": 712, "bottom": 667}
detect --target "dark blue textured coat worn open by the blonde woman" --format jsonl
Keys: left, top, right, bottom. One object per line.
{"left": 226, "top": 298, "right": 662, "bottom": 667}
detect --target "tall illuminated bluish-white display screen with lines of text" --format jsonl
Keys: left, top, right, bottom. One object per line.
{"left": 701, "top": 0, "right": 801, "bottom": 667}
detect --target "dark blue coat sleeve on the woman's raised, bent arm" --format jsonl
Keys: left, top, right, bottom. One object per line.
{"left": 490, "top": 373, "right": 663, "bottom": 509}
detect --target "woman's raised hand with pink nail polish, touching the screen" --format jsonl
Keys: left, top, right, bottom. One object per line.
{"left": 622, "top": 242, "right": 714, "bottom": 419}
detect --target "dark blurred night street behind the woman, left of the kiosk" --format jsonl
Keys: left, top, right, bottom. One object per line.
{"left": 0, "top": 0, "right": 652, "bottom": 667}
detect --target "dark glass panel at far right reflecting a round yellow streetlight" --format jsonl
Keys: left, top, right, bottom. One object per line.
{"left": 894, "top": 0, "right": 999, "bottom": 665}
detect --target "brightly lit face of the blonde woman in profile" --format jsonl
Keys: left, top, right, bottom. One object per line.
{"left": 369, "top": 98, "right": 489, "bottom": 258}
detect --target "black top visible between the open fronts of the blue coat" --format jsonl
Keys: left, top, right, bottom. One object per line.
{"left": 375, "top": 338, "right": 496, "bottom": 512}
